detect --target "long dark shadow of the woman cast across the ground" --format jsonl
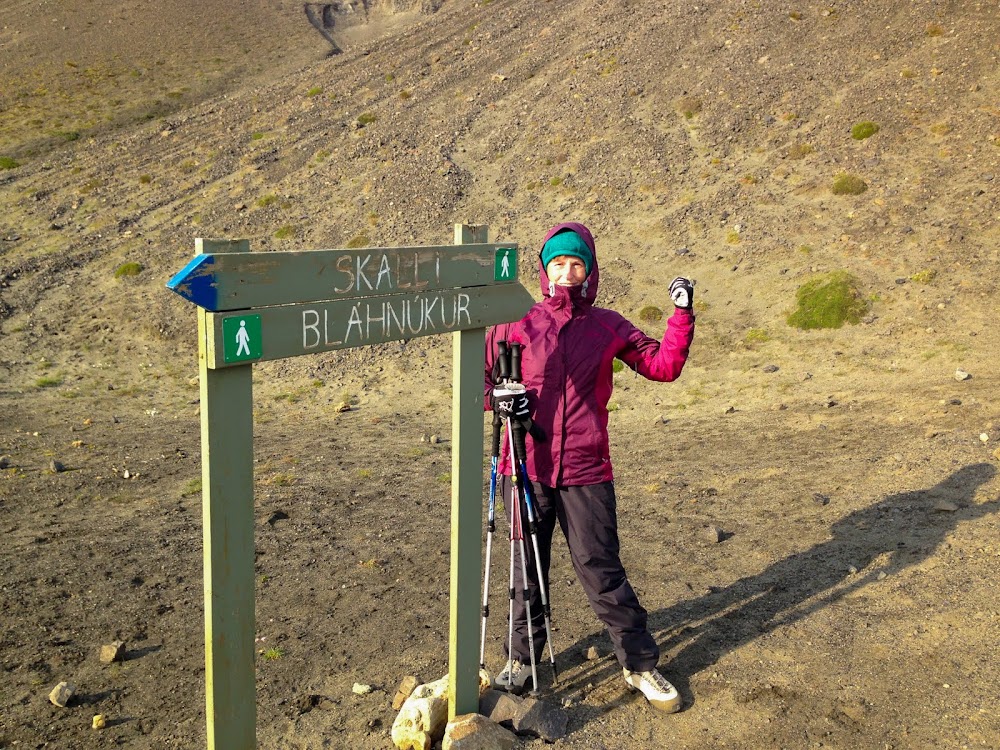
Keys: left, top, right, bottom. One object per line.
{"left": 557, "top": 463, "right": 1000, "bottom": 709}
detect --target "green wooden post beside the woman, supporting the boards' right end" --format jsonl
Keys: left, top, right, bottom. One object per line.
{"left": 448, "top": 224, "right": 488, "bottom": 720}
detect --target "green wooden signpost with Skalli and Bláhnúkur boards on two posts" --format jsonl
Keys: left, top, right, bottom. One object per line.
{"left": 167, "top": 225, "right": 533, "bottom": 750}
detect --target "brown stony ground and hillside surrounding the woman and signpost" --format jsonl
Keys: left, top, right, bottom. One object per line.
{"left": 0, "top": 5, "right": 1000, "bottom": 750}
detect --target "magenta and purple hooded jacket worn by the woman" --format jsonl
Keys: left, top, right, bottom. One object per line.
{"left": 485, "top": 222, "right": 694, "bottom": 487}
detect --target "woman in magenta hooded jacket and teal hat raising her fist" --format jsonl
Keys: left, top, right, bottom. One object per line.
{"left": 485, "top": 223, "right": 695, "bottom": 713}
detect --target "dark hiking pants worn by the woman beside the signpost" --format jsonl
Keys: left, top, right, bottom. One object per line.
{"left": 501, "top": 477, "right": 660, "bottom": 672}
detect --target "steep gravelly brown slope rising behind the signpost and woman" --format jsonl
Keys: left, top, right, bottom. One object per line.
{"left": 0, "top": 0, "right": 1000, "bottom": 400}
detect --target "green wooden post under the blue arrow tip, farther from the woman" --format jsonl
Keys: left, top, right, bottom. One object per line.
{"left": 196, "top": 239, "right": 257, "bottom": 750}
